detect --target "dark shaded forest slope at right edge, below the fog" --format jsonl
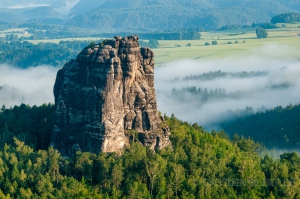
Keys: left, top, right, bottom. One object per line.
{"left": 222, "top": 104, "right": 300, "bottom": 149}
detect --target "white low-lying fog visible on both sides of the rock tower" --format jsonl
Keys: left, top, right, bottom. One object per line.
{"left": 0, "top": 45, "right": 300, "bottom": 128}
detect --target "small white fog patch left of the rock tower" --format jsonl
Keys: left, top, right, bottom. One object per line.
{"left": 0, "top": 65, "right": 58, "bottom": 107}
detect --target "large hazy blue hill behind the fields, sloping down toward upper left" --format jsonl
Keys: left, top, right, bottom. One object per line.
{"left": 69, "top": 0, "right": 300, "bottom": 32}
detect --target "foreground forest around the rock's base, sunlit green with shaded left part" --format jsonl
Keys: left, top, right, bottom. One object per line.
{"left": 0, "top": 104, "right": 300, "bottom": 199}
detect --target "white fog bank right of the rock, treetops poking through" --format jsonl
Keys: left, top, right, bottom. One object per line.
{"left": 155, "top": 45, "right": 300, "bottom": 128}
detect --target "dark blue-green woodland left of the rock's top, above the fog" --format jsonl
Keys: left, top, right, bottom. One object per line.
{"left": 0, "top": 41, "right": 88, "bottom": 68}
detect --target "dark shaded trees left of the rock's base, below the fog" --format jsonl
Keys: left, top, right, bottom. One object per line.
{"left": 0, "top": 104, "right": 54, "bottom": 149}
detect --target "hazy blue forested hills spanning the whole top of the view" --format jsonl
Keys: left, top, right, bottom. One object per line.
{"left": 0, "top": 0, "right": 300, "bottom": 33}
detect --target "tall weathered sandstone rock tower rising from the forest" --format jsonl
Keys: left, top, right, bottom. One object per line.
{"left": 52, "top": 36, "right": 170, "bottom": 155}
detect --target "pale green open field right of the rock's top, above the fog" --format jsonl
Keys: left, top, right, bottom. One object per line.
{"left": 154, "top": 28, "right": 300, "bottom": 65}
